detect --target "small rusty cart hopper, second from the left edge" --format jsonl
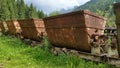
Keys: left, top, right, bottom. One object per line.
{"left": 6, "top": 20, "right": 21, "bottom": 35}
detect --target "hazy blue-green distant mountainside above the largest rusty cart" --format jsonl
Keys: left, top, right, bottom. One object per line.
{"left": 74, "top": 0, "right": 117, "bottom": 12}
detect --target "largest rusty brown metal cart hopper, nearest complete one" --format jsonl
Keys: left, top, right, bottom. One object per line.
{"left": 44, "top": 10, "right": 106, "bottom": 52}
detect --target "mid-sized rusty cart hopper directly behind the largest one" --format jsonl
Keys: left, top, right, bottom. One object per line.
{"left": 18, "top": 19, "right": 45, "bottom": 41}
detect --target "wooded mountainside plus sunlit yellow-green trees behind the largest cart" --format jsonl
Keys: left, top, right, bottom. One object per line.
{"left": 74, "top": 0, "right": 120, "bottom": 26}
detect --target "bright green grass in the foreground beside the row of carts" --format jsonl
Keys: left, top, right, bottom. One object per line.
{"left": 0, "top": 35, "right": 115, "bottom": 68}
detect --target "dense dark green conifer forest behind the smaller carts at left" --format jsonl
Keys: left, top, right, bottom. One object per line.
{"left": 0, "top": 0, "right": 46, "bottom": 21}
